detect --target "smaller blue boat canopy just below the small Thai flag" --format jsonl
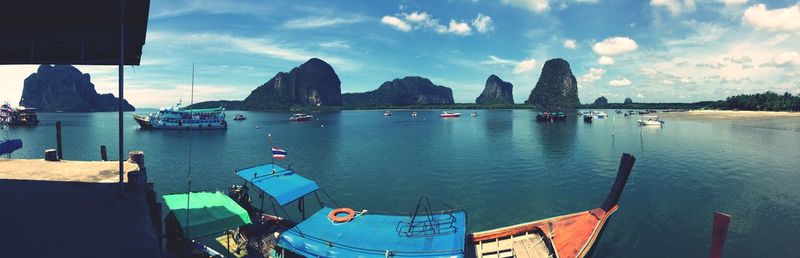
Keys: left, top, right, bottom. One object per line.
{"left": 236, "top": 163, "right": 319, "bottom": 206}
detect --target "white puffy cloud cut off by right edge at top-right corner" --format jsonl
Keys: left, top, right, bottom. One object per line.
{"left": 742, "top": 3, "right": 800, "bottom": 32}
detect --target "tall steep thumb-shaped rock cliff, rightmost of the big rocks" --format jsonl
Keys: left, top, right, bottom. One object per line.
{"left": 525, "top": 58, "right": 580, "bottom": 109}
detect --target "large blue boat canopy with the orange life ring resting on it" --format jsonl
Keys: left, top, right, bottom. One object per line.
{"left": 278, "top": 207, "right": 467, "bottom": 257}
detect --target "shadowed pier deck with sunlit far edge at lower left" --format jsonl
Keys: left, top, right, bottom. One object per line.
{"left": 0, "top": 152, "right": 162, "bottom": 258}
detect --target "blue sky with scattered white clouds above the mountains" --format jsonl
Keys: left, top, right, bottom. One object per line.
{"left": 0, "top": 0, "right": 800, "bottom": 107}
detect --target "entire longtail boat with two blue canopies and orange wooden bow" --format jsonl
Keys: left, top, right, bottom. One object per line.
{"left": 225, "top": 154, "right": 635, "bottom": 257}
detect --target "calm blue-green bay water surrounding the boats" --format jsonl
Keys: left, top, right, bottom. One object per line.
{"left": 0, "top": 110, "right": 800, "bottom": 257}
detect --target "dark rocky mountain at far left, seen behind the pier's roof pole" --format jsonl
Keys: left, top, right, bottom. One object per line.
{"left": 19, "top": 64, "right": 135, "bottom": 112}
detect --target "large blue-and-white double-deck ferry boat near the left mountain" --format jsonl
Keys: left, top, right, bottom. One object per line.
{"left": 133, "top": 102, "right": 228, "bottom": 130}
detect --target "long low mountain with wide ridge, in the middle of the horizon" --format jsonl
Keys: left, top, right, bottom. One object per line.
{"left": 342, "top": 76, "right": 454, "bottom": 107}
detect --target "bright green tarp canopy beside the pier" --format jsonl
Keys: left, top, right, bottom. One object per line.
{"left": 163, "top": 192, "right": 252, "bottom": 239}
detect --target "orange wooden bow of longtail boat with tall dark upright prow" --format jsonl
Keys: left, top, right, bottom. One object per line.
{"left": 469, "top": 153, "right": 636, "bottom": 257}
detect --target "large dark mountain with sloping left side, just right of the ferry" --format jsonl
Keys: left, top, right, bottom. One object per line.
{"left": 239, "top": 58, "right": 342, "bottom": 110}
